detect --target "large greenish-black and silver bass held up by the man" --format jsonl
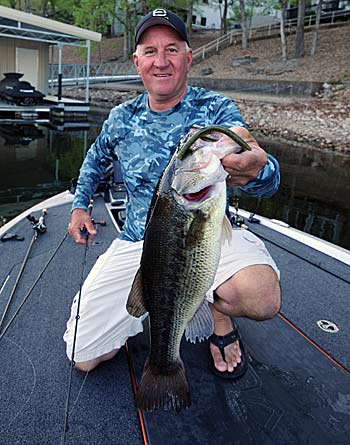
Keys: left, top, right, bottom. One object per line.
{"left": 127, "top": 126, "right": 246, "bottom": 412}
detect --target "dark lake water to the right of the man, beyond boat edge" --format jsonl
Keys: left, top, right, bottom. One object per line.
{"left": 240, "top": 132, "right": 350, "bottom": 249}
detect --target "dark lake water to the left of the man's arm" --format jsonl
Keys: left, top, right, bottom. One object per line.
{"left": 0, "top": 121, "right": 100, "bottom": 223}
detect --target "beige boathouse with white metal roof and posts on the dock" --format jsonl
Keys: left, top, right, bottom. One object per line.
{"left": 0, "top": 6, "right": 101, "bottom": 119}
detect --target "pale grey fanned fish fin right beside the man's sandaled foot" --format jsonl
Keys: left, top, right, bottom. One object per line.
{"left": 185, "top": 300, "right": 214, "bottom": 343}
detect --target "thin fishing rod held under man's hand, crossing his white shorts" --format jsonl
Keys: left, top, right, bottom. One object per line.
{"left": 61, "top": 200, "right": 94, "bottom": 445}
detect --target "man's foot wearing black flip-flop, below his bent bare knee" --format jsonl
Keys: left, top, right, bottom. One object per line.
{"left": 209, "top": 305, "right": 248, "bottom": 379}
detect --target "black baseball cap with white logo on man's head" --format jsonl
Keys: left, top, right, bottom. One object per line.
{"left": 135, "top": 8, "right": 190, "bottom": 48}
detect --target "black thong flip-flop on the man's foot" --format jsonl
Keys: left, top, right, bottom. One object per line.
{"left": 209, "top": 324, "right": 248, "bottom": 380}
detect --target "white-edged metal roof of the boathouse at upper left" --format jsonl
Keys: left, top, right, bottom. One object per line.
{"left": 0, "top": 6, "right": 101, "bottom": 46}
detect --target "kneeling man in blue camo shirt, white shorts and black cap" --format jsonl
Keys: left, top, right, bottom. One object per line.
{"left": 64, "top": 9, "right": 280, "bottom": 378}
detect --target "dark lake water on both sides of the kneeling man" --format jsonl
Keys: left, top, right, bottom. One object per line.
{"left": 0, "top": 111, "right": 350, "bottom": 249}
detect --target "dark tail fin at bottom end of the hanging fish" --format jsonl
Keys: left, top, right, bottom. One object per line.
{"left": 136, "top": 360, "right": 191, "bottom": 412}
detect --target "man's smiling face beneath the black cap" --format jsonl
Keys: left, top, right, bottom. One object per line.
{"left": 133, "top": 25, "right": 192, "bottom": 111}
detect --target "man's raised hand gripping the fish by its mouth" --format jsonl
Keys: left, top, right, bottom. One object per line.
{"left": 221, "top": 127, "right": 267, "bottom": 187}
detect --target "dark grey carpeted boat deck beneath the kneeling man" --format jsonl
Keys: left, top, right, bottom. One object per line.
{"left": 0, "top": 199, "right": 350, "bottom": 445}
